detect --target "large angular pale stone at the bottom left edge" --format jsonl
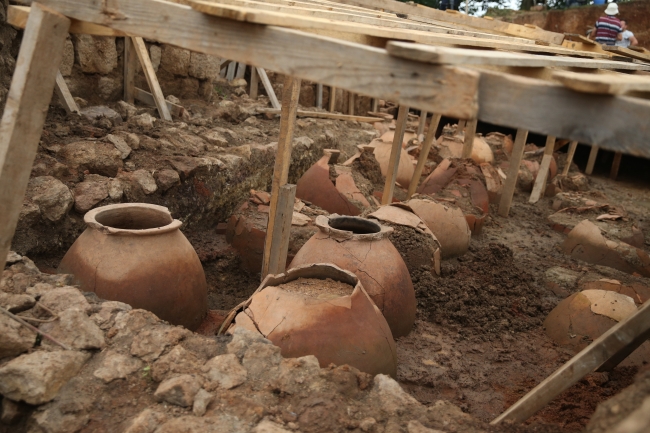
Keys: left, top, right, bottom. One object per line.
{"left": 0, "top": 350, "right": 90, "bottom": 404}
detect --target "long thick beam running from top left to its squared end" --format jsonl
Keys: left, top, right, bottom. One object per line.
{"left": 36, "top": 0, "right": 478, "bottom": 118}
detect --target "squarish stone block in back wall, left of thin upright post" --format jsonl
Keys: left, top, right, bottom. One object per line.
{"left": 73, "top": 34, "right": 117, "bottom": 74}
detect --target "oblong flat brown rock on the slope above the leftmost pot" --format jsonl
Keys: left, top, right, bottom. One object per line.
{"left": 60, "top": 141, "right": 123, "bottom": 177}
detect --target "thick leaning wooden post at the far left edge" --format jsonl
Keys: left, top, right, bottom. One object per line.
{"left": 0, "top": 3, "right": 70, "bottom": 269}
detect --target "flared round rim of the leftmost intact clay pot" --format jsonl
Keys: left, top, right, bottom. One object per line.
{"left": 84, "top": 203, "right": 183, "bottom": 236}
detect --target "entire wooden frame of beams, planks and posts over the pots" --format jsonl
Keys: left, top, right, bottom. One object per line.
{"left": 0, "top": 0, "right": 650, "bottom": 422}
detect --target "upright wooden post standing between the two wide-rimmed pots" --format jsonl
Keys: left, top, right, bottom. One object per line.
{"left": 262, "top": 75, "right": 300, "bottom": 279}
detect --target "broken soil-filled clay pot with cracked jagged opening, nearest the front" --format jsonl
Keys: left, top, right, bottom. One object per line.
{"left": 231, "top": 264, "right": 397, "bottom": 377}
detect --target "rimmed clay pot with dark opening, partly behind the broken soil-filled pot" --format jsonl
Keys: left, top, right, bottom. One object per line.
{"left": 290, "top": 215, "right": 416, "bottom": 337}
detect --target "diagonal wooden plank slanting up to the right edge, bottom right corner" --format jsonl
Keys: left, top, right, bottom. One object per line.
{"left": 490, "top": 302, "right": 650, "bottom": 425}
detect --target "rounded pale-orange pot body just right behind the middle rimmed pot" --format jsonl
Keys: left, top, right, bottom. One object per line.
{"left": 406, "top": 199, "right": 472, "bottom": 259}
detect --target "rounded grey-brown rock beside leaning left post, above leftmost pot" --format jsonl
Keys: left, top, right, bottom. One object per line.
{"left": 27, "top": 176, "right": 74, "bottom": 221}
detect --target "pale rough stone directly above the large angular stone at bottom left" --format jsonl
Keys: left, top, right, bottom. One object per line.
{"left": 40, "top": 309, "right": 106, "bottom": 350}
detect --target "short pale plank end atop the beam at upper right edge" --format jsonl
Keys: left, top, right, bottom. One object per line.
{"left": 553, "top": 71, "right": 650, "bottom": 95}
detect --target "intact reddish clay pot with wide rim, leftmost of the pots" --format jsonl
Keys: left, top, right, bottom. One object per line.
{"left": 58, "top": 203, "right": 208, "bottom": 330}
